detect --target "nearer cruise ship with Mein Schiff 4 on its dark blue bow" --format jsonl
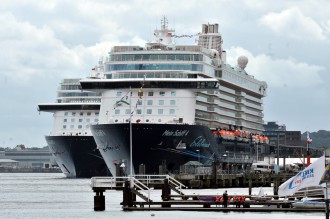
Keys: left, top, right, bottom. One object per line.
{"left": 80, "top": 18, "right": 267, "bottom": 174}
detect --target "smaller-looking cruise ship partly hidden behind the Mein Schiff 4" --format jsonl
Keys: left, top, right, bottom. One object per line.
{"left": 38, "top": 78, "right": 109, "bottom": 178}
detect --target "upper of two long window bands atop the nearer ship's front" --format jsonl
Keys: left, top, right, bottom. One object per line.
{"left": 109, "top": 54, "right": 203, "bottom": 62}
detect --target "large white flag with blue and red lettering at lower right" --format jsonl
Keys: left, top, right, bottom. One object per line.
{"left": 278, "top": 156, "right": 325, "bottom": 197}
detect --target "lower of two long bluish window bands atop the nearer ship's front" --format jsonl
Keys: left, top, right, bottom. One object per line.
{"left": 105, "top": 63, "right": 203, "bottom": 72}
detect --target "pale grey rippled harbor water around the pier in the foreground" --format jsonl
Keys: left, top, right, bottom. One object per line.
{"left": 0, "top": 173, "right": 325, "bottom": 219}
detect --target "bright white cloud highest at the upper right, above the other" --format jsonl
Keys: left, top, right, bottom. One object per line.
{"left": 259, "top": 7, "right": 327, "bottom": 40}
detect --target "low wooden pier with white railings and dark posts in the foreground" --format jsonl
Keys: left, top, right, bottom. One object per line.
{"left": 91, "top": 175, "right": 325, "bottom": 212}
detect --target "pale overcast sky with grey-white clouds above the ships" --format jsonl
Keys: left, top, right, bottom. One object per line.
{"left": 0, "top": 0, "right": 330, "bottom": 147}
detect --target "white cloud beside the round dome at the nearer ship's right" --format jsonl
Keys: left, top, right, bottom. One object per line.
{"left": 227, "top": 47, "right": 324, "bottom": 88}
